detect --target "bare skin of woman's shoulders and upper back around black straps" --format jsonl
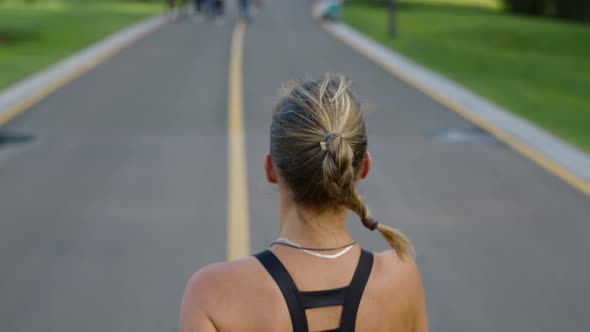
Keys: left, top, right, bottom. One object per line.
{"left": 180, "top": 249, "right": 428, "bottom": 332}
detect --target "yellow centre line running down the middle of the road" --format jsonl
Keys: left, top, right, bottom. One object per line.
{"left": 227, "top": 22, "right": 250, "bottom": 260}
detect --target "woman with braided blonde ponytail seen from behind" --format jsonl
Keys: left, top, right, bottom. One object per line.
{"left": 180, "top": 75, "right": 428, "bottom": 332}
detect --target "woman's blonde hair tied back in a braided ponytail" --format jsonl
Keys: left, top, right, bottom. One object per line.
{"left": 270, "top": 75, "right": 414, "bottom": 258}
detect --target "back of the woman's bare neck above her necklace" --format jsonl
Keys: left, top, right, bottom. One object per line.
{"left": 279, "top": 199, "right": 352, "bottom": 248}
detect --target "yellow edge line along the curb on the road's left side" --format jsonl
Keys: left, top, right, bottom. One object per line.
{"left": 0, "top": 20, "right": 163, "bottom": 126}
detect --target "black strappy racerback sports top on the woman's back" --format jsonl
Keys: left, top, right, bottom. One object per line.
{"left": 254, "top": 250, "right": 373, "bottom": 332}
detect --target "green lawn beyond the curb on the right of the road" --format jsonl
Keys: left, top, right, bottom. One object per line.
{"left": 344, "top": 0, "right": 590, "bottom": 152}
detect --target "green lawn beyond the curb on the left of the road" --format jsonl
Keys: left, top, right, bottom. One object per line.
{"left": 0, "top": 0, "right": 163, "bottom": 89}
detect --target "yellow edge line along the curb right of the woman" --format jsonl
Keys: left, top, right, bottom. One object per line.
{"left": 324, "top": 25, "right": 590, "bottom": 197}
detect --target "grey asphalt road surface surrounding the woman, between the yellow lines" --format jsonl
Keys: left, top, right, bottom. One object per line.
{"left": 0, "top": 0, "right": 590, "bottom": 332}
